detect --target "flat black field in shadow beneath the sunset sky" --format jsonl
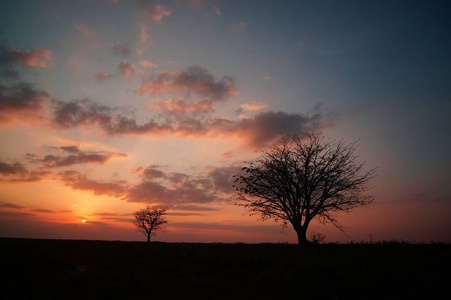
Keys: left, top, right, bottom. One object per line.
{"left": 0, "top": 238, "right": 451, "bottom": 299}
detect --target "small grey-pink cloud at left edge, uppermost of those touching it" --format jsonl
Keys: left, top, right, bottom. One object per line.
{"left": 0, "top": 47, "right": 52, "bottom": 68}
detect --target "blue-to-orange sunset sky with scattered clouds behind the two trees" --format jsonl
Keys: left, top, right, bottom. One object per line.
{"left": 0, "top": 0, "right": 451, "bottom": 243}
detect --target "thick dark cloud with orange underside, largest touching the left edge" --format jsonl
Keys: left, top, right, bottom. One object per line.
{"left": 0, "top": 83, "right": 49, "bottom": 123}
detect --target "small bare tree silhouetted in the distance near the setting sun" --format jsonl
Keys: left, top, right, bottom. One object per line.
{"left": 133, "top": 206, "right": 168, "bottom": 243}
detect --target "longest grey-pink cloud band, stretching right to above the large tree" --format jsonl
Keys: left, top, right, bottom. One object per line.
{"left": 53, "top": 99, "right": 326, "bottom": 149}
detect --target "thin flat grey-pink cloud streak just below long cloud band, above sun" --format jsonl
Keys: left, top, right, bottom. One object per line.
{"left": 30, "top": 146, "right": 127, "bottom": 168}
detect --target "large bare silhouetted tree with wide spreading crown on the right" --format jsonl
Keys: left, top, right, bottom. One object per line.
{"left": 234, "top": 133, "right": 375, "bottom": 244}
